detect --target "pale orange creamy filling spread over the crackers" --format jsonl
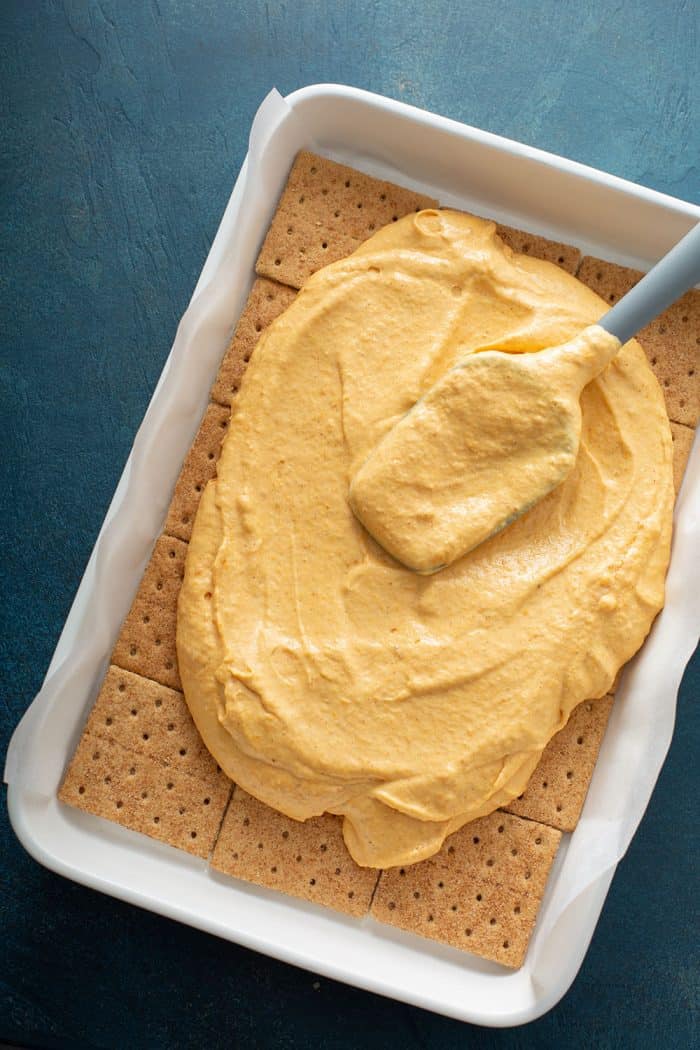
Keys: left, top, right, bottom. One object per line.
{"left": 177, "top": 211, "right": 673, "bottom": 867}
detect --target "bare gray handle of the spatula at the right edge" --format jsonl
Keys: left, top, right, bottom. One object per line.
{"left": 598, "top": 223, "right": 700, "bottom": 343}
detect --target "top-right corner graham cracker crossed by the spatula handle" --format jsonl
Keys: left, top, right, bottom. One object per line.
{"left": 577, "top": 255, "right": 700, "bottom": 427}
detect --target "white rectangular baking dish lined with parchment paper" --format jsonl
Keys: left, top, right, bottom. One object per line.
{"left": 5, "top": 85, "right": 700, "bottom": 1026}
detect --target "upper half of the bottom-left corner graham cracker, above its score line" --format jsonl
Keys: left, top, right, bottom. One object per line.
{"left": 85, "top": 665, "right": 217, "bottom": 780}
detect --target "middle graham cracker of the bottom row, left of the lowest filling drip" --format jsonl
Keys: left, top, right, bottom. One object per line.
{"left": 211, "top": 788, "right": 379, "bottom": 916}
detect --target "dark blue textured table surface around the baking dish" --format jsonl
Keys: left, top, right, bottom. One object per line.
{"left": 0, "top": 0, "right": 700, "bottom": 1050}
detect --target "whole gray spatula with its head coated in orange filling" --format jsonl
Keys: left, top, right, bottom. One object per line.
{"left": 348, "top": 224, "right": 700, "bottom": 573}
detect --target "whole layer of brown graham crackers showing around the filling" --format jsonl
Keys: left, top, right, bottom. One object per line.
{"left": 60, "top": 153, "right": 697, "bottom": 966}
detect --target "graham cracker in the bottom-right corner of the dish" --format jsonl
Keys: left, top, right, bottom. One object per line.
{"left": 369, "top": 813, "right": 561, "bottom": 968}
